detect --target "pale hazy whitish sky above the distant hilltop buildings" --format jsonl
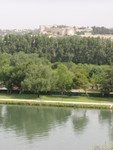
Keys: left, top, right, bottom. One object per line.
{"left": 0, "top": 0, "right": 113, "bottom": 29}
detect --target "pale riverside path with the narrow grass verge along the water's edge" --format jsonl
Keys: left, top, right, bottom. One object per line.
{"left": 0, "top": 99, "right": 113, "bottom": 109}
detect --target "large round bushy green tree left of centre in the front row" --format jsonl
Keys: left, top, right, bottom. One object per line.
{"left": 22, "top": 64, "right": 54, "bottom": 95}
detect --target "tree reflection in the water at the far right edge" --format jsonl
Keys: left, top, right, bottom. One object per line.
{"left": 99, "top": 110, "right": 113, "bottom": 140}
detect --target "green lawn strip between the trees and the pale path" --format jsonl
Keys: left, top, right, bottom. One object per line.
{"left": 0, "top": 94, "right": 113, "bottom": 103}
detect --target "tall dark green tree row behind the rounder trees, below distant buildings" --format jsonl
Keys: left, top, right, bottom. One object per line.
{"left": 0, "top": 34, "right": 113, "bottom": 65}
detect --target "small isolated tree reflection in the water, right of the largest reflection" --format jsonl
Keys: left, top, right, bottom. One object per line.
{"left": 72, "top": 109, "right": 88, "bottom": 133}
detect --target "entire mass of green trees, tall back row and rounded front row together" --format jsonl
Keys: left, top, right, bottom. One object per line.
{"left": 0, "top": 34, "right": 113, "bottom": 94}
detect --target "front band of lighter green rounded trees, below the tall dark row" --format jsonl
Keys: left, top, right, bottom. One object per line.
{"left": 0, "top": 52, "right": 113, "bottom": 94}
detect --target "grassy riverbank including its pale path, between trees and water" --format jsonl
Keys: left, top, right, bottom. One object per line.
{"left": 0, "top": 94, "right": 113, "bottom": 109}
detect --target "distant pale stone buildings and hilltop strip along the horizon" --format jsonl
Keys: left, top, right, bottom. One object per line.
{"left": 0, "top": 25, "right": 113, "bottom": 39}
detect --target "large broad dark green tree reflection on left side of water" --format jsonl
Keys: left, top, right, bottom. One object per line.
{"left": 0, "top": 106, "right": 72, "bottom": 138}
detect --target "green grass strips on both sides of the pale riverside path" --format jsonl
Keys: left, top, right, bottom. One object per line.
{"left": 0, "top": 94, "right": 113, "bottom": 109}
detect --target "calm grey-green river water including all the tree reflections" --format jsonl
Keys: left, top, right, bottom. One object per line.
{"left": 0, "top": 105, "right": 113, "bottom": 150}
